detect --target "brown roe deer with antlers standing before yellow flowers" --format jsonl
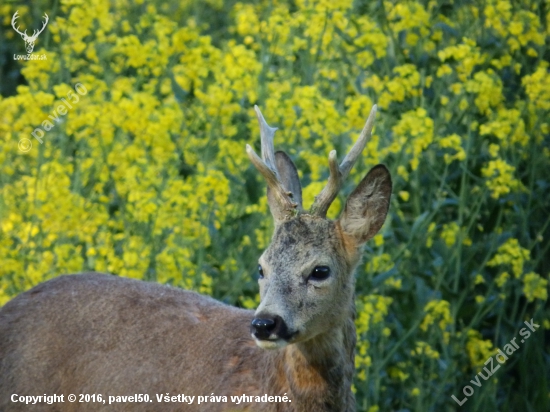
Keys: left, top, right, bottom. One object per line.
{"left": 0, "top": 106, "right": 391, "bottom": 412}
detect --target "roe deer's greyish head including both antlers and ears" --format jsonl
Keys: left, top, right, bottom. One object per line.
{"left": 246, "top": 106, "right": 391, "bottom": 349}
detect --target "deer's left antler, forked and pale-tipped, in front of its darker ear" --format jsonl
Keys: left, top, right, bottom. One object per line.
{"left": 246, "top": 105, "right": 301, "bottom": 220}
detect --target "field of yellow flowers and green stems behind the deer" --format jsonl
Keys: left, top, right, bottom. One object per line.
{"left": 0, "top": 0, "right": 550, "bottom": 412}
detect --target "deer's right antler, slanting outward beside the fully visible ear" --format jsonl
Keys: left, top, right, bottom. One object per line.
{"left": 310, "top": 105, "right": 377, "bottom": 217}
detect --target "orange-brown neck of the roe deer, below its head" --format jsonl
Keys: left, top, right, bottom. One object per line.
{"left": 266, "top": 309, "right": 356, "bottom": 411}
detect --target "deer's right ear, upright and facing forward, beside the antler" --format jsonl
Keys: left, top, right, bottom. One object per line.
{"left": 339, "top": 165, "right": 392, "bottom": 245}
